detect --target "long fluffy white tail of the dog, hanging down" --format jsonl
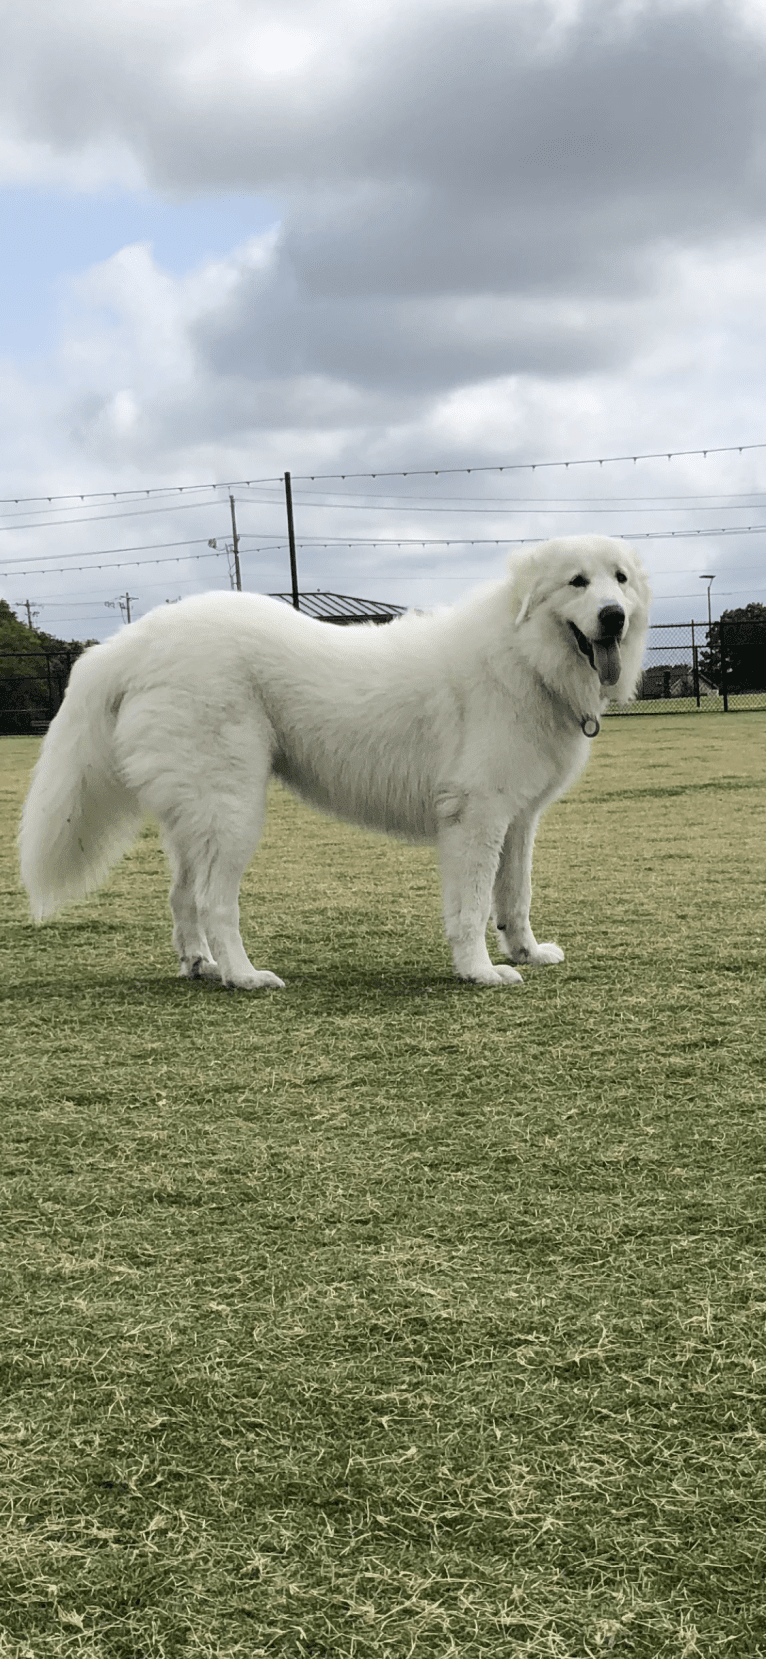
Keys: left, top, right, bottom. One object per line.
{"left": 18, "top": 642, "right": 143, "bottom": 921}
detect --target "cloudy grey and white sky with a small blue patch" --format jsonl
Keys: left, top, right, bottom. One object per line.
{"left": 0, "top": 0, "right": 766, "bottom": 637}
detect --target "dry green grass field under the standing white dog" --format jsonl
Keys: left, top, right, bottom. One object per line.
{"left": 0, "top": 715, "right": 766, "bottom": 1659}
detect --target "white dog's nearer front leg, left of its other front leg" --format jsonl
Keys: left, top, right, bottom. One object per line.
{"left": 438, "top": 795, "right": 521, "bottom": 985}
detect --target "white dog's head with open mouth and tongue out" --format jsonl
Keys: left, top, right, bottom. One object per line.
{"left": 511, "top": 536, "right": 650, "bottom": 703}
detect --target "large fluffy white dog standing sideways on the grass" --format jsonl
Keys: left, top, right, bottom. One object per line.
{"left": 20, "top": 536, "right": 650, "bottom": 990}
